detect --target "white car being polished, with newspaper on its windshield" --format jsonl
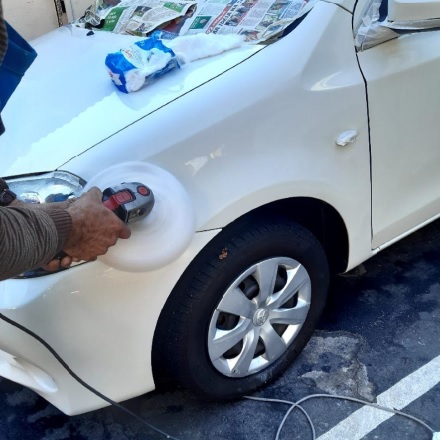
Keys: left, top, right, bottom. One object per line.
{"left": 0, "top": 0, "right": 440, "bottom": 414}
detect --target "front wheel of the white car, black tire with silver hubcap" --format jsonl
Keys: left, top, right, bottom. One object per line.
{"left": 153, "top": 216, "right": 329, "bottom": 400}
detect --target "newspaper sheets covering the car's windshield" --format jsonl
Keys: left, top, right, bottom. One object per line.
{"left": 76, "top": 0, "right": 319, "bottom": 43}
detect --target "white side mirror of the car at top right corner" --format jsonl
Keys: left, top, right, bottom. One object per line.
{"left": 390, "top": 0, "right": 440, "bottom": 21}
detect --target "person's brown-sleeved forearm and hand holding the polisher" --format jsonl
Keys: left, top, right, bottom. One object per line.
{"left": 0, "top": 183, "right": 131, "bottom": 280}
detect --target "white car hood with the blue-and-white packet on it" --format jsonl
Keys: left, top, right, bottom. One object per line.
{"left": 0, "top": 26, "right": 262, "bottom": 177}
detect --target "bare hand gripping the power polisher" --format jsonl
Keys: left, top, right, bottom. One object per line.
{"left": 62, "top": 187, "right": 131, "bottom": 267}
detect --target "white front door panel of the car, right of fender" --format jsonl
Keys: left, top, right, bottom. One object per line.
{"left": 358, "top": 0, "right": 440, "bottom": 248}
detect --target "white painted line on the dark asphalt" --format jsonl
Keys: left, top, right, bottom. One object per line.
{"left": 318, "top": 356, "right": 440, "bottom": 440}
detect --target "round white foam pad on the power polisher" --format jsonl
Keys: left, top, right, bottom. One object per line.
{"left": 84, "top": 162, "right": 195, "bottom": 272}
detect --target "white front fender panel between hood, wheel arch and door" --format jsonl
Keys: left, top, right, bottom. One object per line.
{"left": 64, "top": 2, "right": 371, "bottom": 267}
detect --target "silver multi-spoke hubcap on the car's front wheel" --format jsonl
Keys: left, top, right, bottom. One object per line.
{"left": 208, "top": 257, "right": 311, "bottom": 377}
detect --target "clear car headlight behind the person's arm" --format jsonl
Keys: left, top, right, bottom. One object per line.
{"left": 5, "top": 171, "right": 86, "bottom": 278}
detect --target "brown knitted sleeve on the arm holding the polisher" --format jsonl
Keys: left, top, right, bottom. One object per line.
{"left": 0, "top": 206, "right": 72, "bottom": 280}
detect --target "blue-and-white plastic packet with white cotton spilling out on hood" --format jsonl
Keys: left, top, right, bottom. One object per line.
{"left": 105, "top": 34, "right": 243, "bottom": 93}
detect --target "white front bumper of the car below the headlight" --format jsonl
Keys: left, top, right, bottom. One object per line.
{"left": 0, "top": 230, "right": 219, "bottom": 415}
